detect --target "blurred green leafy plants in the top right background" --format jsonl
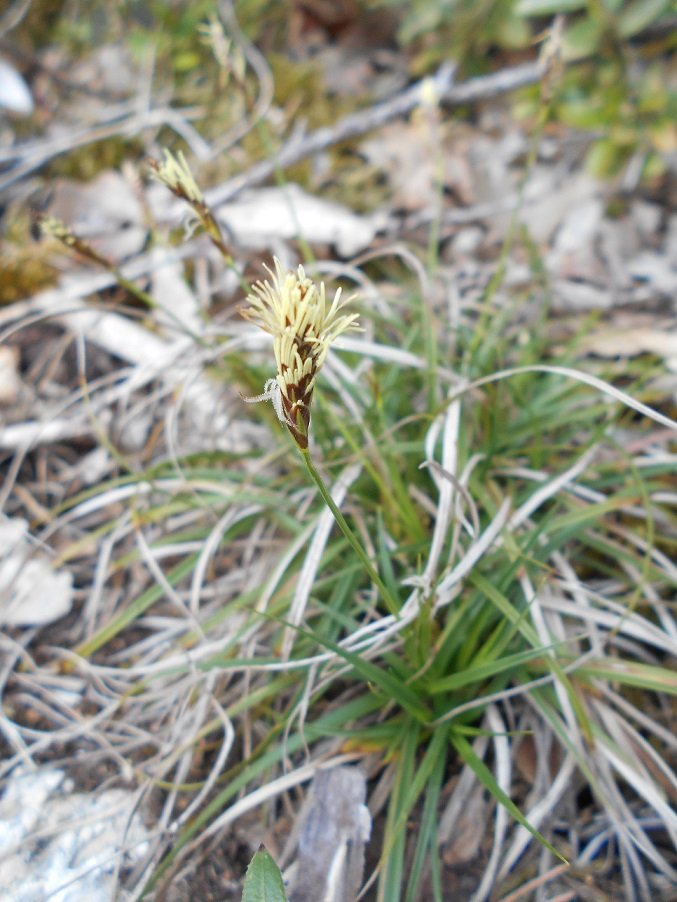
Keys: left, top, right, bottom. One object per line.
{"left": 372, "top": 0, "right": 677, "bottom": 181}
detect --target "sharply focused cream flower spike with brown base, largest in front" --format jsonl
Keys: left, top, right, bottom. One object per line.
{"left": 240, "top": 257, "right": 359, "bottom": 450}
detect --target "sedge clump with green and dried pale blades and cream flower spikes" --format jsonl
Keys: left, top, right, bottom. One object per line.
{"left": 18, "top": 141, "right": 677, "bottom": 902}
